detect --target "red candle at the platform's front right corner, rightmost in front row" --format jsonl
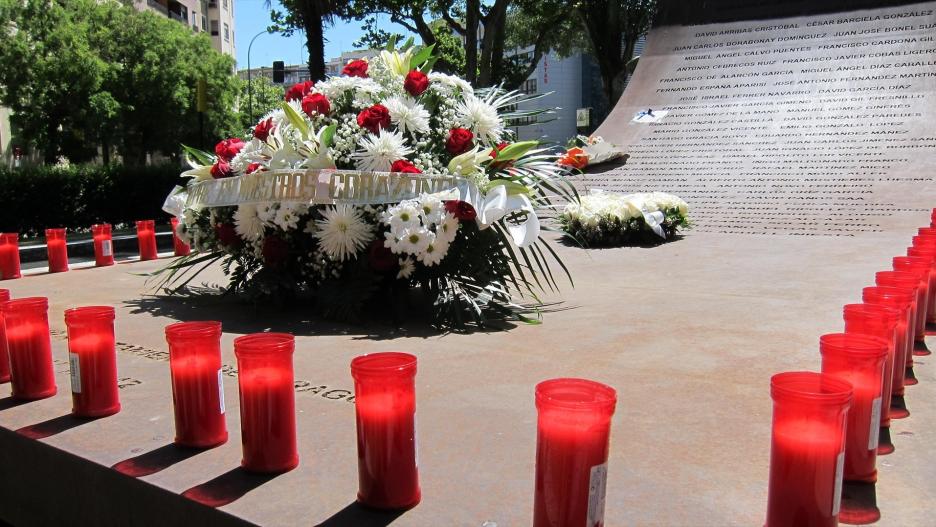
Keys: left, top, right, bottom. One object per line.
{"left": 766, "top": 372, "right": 852, "bottom": 527}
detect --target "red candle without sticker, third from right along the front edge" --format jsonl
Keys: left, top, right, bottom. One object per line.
{"left": 351, "top": 353, "right": 421, "bottom": 509}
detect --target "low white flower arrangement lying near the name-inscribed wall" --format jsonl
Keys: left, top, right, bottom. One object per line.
{"left": 559, "top": 190, "right": 691, "bottom": 247}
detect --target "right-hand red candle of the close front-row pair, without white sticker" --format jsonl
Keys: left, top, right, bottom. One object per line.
{"left": 234, "top": 333, "right": 299, "bottom": 473}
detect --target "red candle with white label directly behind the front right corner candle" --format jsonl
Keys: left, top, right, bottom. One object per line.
{"left": 819, "top": 333, "right": 887, "bottom": 483}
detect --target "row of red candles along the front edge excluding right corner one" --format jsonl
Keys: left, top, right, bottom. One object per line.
{"left": 0, "top": 296, "right": 617, "bottom": 526}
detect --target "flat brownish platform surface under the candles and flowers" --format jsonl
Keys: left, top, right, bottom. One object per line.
{"left": 0, "top": 224, "right": 936, "bottom": 527}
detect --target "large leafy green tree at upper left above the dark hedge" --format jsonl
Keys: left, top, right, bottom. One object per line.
{"left": 0, "top": 0, "right": 240, "bottom": 164}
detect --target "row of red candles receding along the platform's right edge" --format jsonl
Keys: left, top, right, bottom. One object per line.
{"left": 766, "top": 209, "right": 936, "bottom": 527}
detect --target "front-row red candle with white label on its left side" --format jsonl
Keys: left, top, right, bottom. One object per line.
{"left": 65, "top": 306, "right": 120, "bottom": 417}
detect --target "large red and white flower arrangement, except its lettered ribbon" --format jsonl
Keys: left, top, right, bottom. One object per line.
{"left": 163, "top": 46, "right": 577, "bottom": 327}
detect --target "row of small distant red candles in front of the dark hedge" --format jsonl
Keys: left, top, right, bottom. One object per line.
{"left": 0, "top": 218, "right": 191, "bottom": 280}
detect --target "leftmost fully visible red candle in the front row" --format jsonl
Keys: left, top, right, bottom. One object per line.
{"left": 0, "top": 297, "right": 56, "bottom": 400}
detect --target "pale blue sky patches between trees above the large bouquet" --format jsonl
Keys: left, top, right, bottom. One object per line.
{"left": 234, "top": 0, "right": 414, "bottom": 69}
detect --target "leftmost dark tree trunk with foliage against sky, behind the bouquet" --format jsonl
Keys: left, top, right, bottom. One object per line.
{"left": 265, "top": 0, "right": 343, "bottom": 80}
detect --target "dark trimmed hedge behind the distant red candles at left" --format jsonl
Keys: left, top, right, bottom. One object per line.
{"left": 0, "top": 164, "right": 179, "bottom": 235}
